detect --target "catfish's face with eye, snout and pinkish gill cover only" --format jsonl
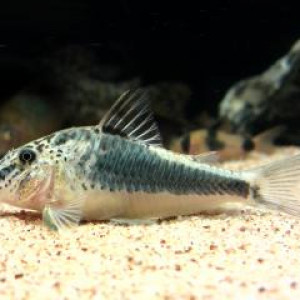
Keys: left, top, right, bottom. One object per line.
{"left": 0, "top": 144, "right": 54, "bottom": 210}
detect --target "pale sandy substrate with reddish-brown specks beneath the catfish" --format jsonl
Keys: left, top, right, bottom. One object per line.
{"left": 0, "top": 149, "right": 300, "bottom": 299}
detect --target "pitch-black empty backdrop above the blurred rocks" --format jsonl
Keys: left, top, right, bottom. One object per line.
{"left": 0, "top": 0, "right": 300, "bottom": 115}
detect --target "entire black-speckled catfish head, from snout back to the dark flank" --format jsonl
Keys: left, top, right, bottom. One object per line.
{"left": 0, "top": 131, "right": 88, "bottom": 211}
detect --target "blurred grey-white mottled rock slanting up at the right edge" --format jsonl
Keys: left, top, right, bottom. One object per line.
{"left": 219, "top": 40, "right": 300, "bottom": 134}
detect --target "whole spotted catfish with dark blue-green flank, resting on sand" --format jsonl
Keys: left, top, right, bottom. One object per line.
{"left": 0, "top": 90, "right": 300, "bottom": 230}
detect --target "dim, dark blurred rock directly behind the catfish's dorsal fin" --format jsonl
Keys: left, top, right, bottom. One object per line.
{"left": 43, "top": 46, "right": 192, "bottom": 135}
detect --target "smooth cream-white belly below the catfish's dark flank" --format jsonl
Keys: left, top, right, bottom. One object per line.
{"left": 83, "top": 191, "right": 247, "bottom": 220}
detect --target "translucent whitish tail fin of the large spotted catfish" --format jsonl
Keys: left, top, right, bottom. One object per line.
{"left": 243, "top": 154, "right": 300, "bottom": 216}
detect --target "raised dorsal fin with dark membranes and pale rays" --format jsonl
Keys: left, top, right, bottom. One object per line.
{"left": 98, "top": 89, "right": 162, "bottom": 146}
